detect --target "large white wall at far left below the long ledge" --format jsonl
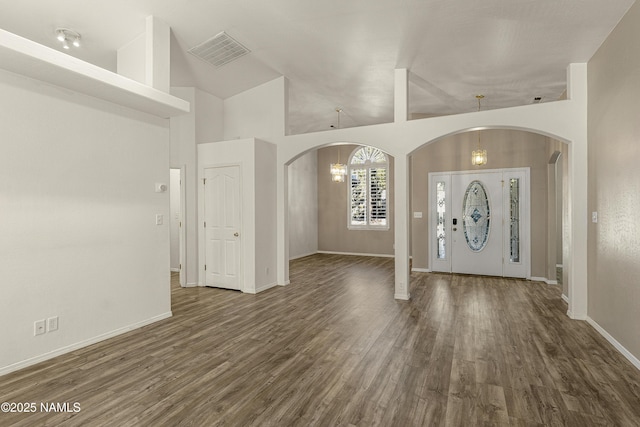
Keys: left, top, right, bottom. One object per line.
{"left": 0, "top": 71, "right": 171, "bottom": 374}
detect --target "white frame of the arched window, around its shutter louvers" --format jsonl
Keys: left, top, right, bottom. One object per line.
{"left": 347, "top": 145, "right": 391, "bottom": 231}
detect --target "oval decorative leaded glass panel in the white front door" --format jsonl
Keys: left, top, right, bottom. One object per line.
{"left": 462, "top": 181, "right": 491, "bottom": 252}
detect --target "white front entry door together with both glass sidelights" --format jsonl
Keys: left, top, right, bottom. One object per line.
{"left": 429, "top": 169, "right": 529, "bottom": 278}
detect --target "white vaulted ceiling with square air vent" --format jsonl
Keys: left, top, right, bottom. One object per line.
{"left": 0, "top": 0, "right": 634, "bottom": 133}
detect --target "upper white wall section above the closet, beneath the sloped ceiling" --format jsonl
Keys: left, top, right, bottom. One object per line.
{"left": 224, "top": 77, "right": 288, "bottom": 141}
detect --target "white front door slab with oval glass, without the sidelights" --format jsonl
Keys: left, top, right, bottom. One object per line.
{"left": 451, "top": 172, "right": 503, "bottom": 276}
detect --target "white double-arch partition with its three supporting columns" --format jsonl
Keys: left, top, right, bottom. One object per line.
{"left": 277, "top": 64, "right": 588, "bottom": 319}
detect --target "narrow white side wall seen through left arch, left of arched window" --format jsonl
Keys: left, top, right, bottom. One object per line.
{"left": 288, "top": 150, "right": 318, "bottom": 259}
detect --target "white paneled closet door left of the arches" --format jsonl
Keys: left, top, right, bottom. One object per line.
{"left": 204, "top": 166, "right": 241, "bottom": 290}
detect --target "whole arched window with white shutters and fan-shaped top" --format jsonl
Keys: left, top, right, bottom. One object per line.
{"left": 349, "top": 146, "right": 389, "bottom": 230}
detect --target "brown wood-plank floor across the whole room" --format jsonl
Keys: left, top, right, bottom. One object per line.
{"left": 0, "top": 255, "right": 640, "bottom": 427}
